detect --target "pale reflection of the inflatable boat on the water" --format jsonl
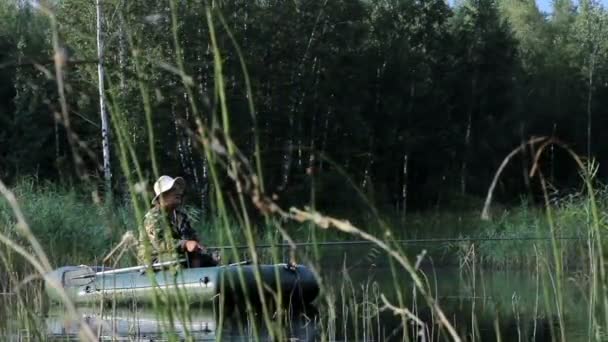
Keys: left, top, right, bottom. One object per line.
{"left": 46, "top": 307, "right": 316, "bottom": 341}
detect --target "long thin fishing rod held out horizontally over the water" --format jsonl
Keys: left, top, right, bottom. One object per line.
{"left": 208, "top": 236, "right": 583, "bottom": 249}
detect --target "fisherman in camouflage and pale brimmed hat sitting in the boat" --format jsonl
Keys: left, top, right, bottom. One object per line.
{"left": 138, "top": 176, "right": 218, "bottom": 267}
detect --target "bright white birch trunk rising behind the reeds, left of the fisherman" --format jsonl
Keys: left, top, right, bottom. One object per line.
{"left": 95, "top": 0, "right": 112, "bottom": 195}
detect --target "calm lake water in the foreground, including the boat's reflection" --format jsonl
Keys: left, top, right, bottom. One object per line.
{"left": 0, "top": 244, "right": 588, "bottom": 341}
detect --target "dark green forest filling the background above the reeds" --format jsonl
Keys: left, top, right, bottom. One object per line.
{"left": 0, "top": 0, "right": 608, "bottom": 214}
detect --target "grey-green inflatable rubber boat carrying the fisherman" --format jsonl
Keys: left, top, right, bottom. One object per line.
{"left": 45, "top": 263, "right": 319, "bottom": 305}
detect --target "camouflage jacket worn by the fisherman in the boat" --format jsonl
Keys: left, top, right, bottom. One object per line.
{"left": 138, "top": 206, "right": 198, "bottom": 261}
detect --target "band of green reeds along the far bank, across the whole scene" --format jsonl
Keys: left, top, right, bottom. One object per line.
{"left": 0, "top": 178, "right": 592, "bottom": 268}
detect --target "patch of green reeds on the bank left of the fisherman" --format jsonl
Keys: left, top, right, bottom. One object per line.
{"left": 0, "top": 179, "right": 120, "bottom": 265}
